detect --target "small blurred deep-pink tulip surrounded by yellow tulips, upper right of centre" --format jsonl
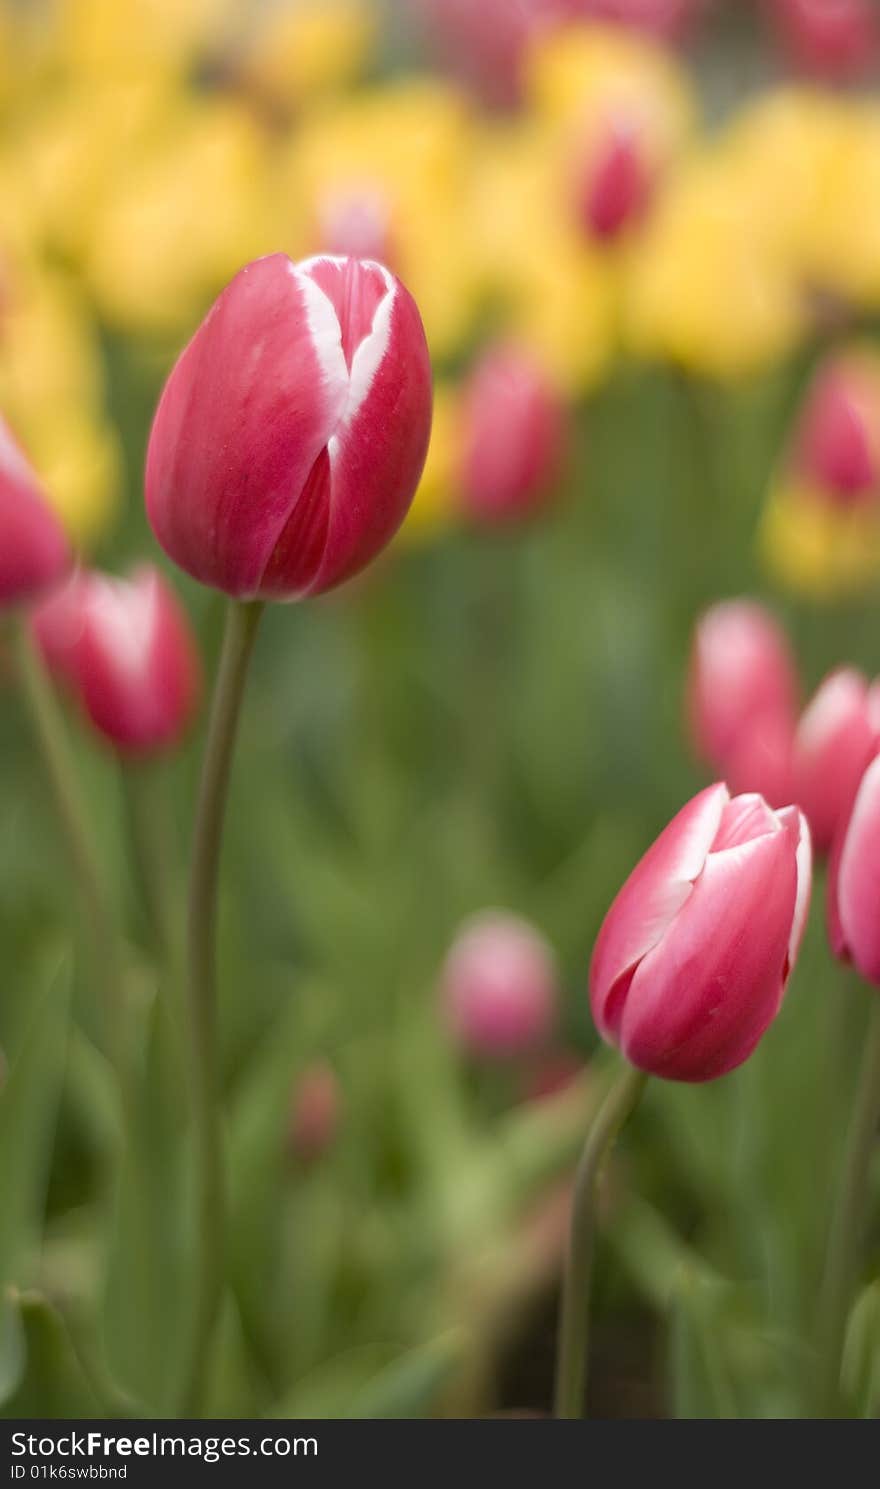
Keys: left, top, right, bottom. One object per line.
{"left": 575, "top": 121, "right": 654, "bottom": 243}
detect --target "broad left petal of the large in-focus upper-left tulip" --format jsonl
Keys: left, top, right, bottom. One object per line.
{"left": 146, "top": 253, "right": 350, "bottom": 597}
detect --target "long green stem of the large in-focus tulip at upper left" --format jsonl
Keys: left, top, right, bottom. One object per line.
{"left": 180, "top": 600, "right": 262, "bottom": 1416}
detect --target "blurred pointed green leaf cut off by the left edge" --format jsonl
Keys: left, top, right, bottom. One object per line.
{"left": 0, "top": 956, "right": 70, "bottom": 1285}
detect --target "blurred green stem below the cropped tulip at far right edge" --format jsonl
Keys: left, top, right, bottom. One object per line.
{"left": 817, "top": 995, "right": 880, "bottom": 1416}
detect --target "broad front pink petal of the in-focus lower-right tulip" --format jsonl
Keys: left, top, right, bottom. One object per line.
{"left": 619, "top": 828, "right": 798, "bottom": 1081}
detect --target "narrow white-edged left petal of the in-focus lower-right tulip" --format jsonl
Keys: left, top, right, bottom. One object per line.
{"left": 590, "top": 783, "right": 730, "bottom": 1039}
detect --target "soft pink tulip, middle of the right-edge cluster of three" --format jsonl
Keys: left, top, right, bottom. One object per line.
{"left": 794, "top": 667, "right": 880, "bottom": 853}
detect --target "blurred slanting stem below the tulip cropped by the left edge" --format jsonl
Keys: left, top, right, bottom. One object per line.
{"left": 12, "top": 615, "right": 128, "bottom": 1100}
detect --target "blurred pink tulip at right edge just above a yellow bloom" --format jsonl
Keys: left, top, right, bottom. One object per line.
{"left": 795, "top": 356, "right": 880, "bottom": 506}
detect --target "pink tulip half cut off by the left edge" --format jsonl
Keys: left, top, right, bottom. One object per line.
{"left": 0, "top": 418, "right": 71, "bottom": 609}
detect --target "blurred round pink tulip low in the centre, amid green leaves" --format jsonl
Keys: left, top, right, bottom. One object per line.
{"left": 441, "top": 911, "right": 557, "bottom": 1060}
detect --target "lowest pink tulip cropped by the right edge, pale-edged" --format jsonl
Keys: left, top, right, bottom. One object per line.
{"left": 828, "top": 756, "right": 880, "bottom": 987}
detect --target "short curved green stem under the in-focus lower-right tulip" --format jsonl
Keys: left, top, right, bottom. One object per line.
{"left": 555, "top": 1065, "right": 648, "bottom": 1421}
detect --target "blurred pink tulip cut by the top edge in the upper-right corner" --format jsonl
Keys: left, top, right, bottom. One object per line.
{"left": 765, "top": 0, "right": 880, "bottom": 82}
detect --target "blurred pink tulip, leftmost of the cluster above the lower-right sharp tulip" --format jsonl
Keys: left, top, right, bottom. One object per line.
{"left": 688, "top": 600, "right": 798, "bottom": 806}
